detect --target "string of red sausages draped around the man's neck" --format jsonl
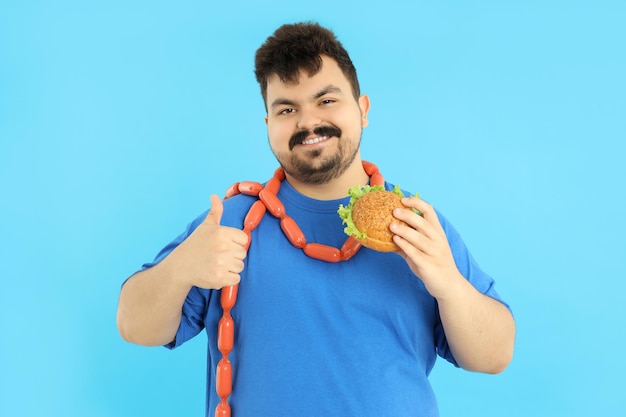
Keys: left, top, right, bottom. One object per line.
{"left": 215, "top": 161, "right": 385, "bottom": 417}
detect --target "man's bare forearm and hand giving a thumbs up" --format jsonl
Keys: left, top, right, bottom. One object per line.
{"left": 117, "top": 195, "right": 248, "bottom": 346}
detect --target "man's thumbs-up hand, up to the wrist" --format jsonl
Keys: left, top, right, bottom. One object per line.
{"left": 168, "top": 195, "right": 248, "bottom": 289}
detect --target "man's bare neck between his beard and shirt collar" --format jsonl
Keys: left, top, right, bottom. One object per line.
{"left": 286, "top": 158, "right": 369, "bottom": 200}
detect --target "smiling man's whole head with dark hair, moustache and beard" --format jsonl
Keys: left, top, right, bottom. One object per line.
{"left": 256, "top": 23, "right": 369, "bottom": 185}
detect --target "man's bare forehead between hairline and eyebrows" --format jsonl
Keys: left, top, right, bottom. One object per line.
{"left": 267, "top": 55, "right": 352, "bottom": 104}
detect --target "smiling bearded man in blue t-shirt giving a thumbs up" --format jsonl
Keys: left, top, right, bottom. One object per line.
{"left": 118, "top": 23, "right": 515, "bottom": 417}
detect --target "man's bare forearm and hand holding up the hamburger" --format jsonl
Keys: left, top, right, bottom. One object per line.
{"left": 390, "top": 197, "right": 515, "bottom": 373}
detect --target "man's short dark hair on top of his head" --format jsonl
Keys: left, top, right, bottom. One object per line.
{"left": 254, "top": 22, "right": 361, "bottom": 103}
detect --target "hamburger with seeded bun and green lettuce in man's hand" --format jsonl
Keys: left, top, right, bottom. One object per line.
{"left": 337, "top": 185, "right": 420, "bottom": 252}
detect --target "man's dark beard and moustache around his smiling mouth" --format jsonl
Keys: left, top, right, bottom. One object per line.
{"left": 273, "top": 126, "right": 361, "bottom": 185}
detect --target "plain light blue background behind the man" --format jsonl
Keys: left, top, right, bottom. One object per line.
{"left": 0, "top": 0, "right": 626, "bottom": 417}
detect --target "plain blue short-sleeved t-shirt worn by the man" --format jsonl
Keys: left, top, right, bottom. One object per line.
{"left": 144, "top": 181, "right": 508, "bottom": 417}
